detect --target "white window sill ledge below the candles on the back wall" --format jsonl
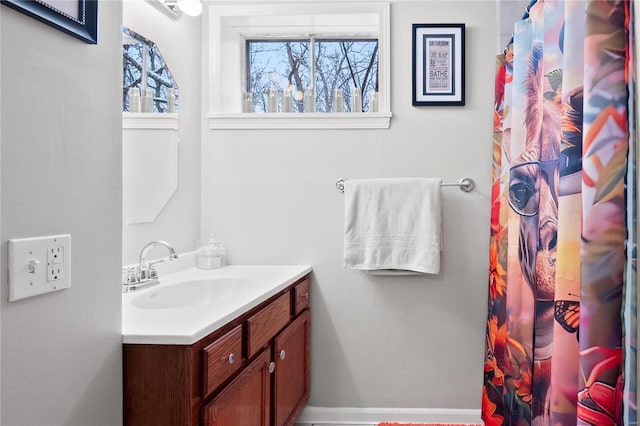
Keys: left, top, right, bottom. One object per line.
{"left": 207, "top": 112, "right": 391, "bottom": 130}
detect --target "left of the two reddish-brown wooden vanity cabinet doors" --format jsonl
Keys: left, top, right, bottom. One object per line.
{"left": 203, "top": 348, "right": 271, "bottom": 426}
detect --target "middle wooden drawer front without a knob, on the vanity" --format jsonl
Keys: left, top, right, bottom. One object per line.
{"left": 245, "top": 292, "right": 291, "bottom": 358}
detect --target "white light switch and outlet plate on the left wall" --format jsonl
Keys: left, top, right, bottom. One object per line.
{"left": 8, "top": 234, "right": 71, "bottom": 302}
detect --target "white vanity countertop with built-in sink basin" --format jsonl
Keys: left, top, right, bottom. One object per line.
{"left": 122, "top": 265, "right": 311, "bottom": 345}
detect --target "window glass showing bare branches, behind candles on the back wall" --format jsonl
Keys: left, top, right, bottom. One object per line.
{"left": 245, "top": 37, "right": 378, "bottom": 112}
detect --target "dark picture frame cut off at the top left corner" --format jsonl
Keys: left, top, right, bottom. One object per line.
{"left": 0, "top": 0, "right": 98, "bottom": 44}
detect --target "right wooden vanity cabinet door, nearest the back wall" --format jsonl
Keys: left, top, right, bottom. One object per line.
{"left": 274, "top": 310, "right": 310, "bottom": 426}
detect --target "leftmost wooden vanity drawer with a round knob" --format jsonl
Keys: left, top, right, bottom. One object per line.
{"left": 202, "top": 325, "right": 242, "bottom": 396}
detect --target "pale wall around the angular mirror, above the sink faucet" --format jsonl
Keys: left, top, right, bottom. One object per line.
{"left": 122, "top": 0, "right": 202, "bottom": 265}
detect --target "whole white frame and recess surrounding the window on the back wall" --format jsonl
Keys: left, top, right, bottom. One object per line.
{"left": 208, "top": 2, "right": 392, "bottom": 129}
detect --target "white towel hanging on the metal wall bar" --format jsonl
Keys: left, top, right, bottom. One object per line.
{"left": 344, "top": 178, "right": 442, "bottom": 274}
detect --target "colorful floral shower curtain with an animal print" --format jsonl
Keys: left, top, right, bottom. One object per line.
{"left": 482, "top": 0, "right": 638, "bottom": 426}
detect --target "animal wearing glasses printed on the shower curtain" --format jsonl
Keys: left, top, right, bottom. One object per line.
{"left": 509, "top": 40, "right": 562, "bottom": 425}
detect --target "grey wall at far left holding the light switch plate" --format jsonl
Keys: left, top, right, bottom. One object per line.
{"left": 0, "top": 1, "right": 122, "bottom": 426}
